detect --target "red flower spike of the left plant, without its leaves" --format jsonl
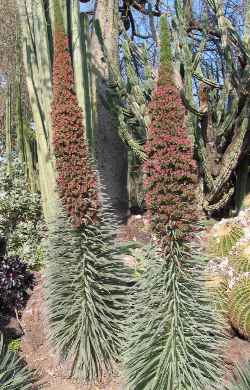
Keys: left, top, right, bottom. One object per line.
{"left": 52, "top": 5, "right": 99, "bottom": 228}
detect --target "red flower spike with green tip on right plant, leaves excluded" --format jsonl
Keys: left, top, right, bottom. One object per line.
{"left": 144, "top": 18, "right": 198, "bottom": 246}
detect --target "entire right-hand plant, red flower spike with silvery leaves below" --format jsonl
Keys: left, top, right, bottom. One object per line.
{"left": 124, "top": 18, "right": 222, "bottom": 390}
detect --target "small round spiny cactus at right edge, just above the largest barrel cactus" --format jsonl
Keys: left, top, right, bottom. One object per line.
{"left": 228, "top": 242, "right": 250, "bottom": 273}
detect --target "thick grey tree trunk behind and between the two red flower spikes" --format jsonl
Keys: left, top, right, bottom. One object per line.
{"left": 90, "top": 0, "right": 128, "bottom": 218}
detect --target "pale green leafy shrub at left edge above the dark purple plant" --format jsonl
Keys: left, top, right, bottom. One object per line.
{"left": 0, "top": 159, "right": 45, "bottom": 269}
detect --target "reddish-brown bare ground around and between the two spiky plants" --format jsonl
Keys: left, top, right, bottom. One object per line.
{"left": 21, "top": 216, "right": 250, "bottom": 390}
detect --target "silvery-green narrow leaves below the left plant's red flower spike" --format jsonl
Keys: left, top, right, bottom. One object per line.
{"left": 46, "top": 212, "right": 132, "bottom": 382}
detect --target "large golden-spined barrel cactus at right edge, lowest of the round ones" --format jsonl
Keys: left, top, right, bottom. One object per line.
{"left": 229, "top": 277, "right": 250, "bottom": 339}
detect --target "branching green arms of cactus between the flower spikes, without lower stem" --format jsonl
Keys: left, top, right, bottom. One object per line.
{"left": 105, "top": 33, "right": 153, "bottom": 161}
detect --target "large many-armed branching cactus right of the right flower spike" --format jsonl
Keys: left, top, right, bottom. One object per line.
{"left": 173, "top": 0, "right": 250, "bottom": 213}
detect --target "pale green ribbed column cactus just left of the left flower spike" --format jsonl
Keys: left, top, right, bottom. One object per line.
{"left": 17, "top": 0, "right": 58, "bottom": 222}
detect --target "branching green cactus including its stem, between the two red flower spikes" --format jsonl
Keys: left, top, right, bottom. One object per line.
{"left": 100, "top": 31, "right": 154, "bottom": 208}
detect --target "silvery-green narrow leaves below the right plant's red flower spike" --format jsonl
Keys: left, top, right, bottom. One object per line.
{"left": 124, "top": 239, "right": 225, "bottom": 390}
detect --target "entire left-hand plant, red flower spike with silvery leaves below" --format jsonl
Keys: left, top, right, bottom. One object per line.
{"left": 45, "top": 0, "right": 132, "bottom": 383}
